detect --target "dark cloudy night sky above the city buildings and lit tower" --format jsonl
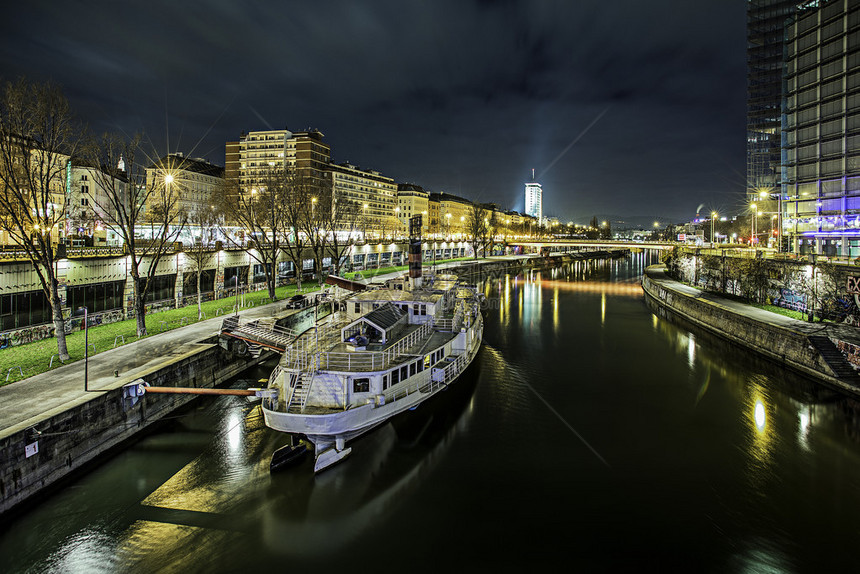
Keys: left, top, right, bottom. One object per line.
{"left": 0, "top": 0, "right": 746, "bottom": 225}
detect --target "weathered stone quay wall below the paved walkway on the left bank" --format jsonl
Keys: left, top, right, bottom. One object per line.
{"left": 0, "top": 342, "right": 266, "bottom": 513}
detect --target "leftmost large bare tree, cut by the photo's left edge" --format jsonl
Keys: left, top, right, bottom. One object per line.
{"left": 0, "top": 79, "right": 81, "bottom": 360}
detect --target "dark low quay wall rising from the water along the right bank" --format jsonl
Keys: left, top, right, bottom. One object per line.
{"left": 642, "top": 272, "right": 857, "bottom": 394}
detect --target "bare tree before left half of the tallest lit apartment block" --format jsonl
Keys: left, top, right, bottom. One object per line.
{"left": 213, "top": 174, "right": 280, "bottom": 301}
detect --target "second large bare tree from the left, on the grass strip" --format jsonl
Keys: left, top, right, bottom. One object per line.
{"left": 84, "top": 134, "right": 187, "bottom": 337}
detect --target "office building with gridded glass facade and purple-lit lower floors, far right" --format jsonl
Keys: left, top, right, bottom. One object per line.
{"left": 781, "top": 0, "right": 860, "bottom": 257}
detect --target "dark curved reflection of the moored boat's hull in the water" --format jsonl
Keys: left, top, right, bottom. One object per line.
{"left": 262, "top": 362, "right": 484, "bottom": 557}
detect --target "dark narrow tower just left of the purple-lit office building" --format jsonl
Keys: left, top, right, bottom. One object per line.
{"left": 746, "top": 0, "right": 802, "bottom": 199}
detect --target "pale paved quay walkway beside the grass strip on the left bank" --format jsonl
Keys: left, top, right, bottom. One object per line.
{"left": 0, "top": 256, "right": 522, "bottom": 437}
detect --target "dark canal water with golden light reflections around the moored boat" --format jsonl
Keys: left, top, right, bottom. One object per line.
{"left": 0, "top": 253, "right": 860, "bottom": 573}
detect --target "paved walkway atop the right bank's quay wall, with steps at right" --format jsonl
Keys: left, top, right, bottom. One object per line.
{"left": 645, "top": 265, "right": 860, "bottom": 390}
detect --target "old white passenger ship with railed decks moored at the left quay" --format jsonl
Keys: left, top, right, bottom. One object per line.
{"left": 262, "top": 266, "right": 483, "bottom": 471}
